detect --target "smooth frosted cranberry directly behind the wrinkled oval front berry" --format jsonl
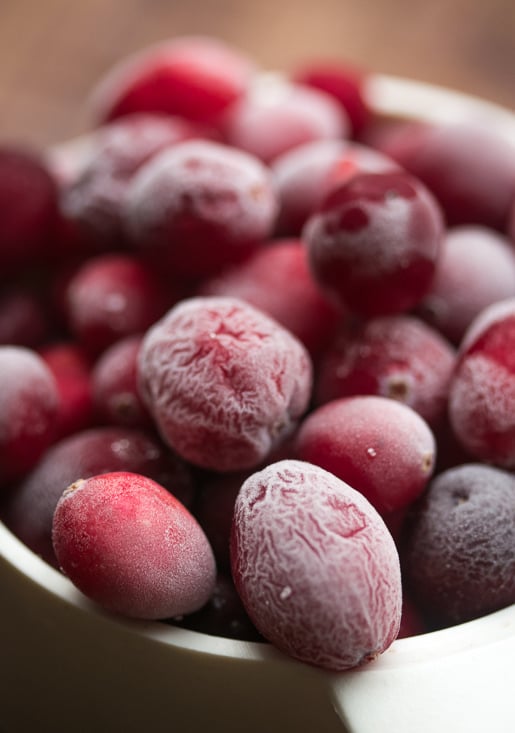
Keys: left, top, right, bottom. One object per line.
{"left": 297, "top": 395, "right": 436, "bottom": 514}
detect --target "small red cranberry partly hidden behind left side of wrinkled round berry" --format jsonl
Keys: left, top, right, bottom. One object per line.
{"left": 91, "top": 336, "right": 152, "bottom": 428}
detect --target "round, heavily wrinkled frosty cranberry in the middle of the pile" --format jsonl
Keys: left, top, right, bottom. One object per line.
{"left": 139, "top": 297, "right": 312, "bottom": 471}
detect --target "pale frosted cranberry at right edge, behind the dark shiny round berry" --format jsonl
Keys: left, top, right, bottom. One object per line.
{"left": 417, "top": 226, "right": 515, "bottom": 343}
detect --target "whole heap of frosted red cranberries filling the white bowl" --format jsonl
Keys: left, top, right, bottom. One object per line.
{"left": 0, "top": 37, "right": 515, "bottom": 670}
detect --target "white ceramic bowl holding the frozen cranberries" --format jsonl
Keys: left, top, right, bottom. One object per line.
{"left": 0, "top": 76, "right": 515, "bottom": 733}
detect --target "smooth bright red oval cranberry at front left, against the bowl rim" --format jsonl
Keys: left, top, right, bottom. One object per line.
{"left": 52, "top": 472, "right": 216, "bottom": 619}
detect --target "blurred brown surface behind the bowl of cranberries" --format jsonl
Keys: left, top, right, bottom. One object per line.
{"left": 0, "top": 0, "right": 515, "bottom": 145}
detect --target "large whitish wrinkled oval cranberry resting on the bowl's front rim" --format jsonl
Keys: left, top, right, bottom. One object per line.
{"left": 231, "top": 460, "right": 402, "bottom": 671}
